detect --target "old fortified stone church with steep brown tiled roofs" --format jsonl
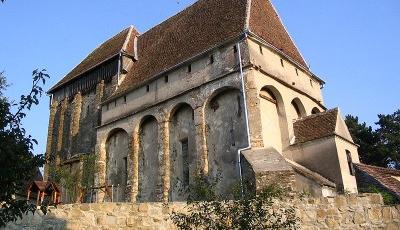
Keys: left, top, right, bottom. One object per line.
{"left": 44, "top": 0, "right": 359, "bottom": 202}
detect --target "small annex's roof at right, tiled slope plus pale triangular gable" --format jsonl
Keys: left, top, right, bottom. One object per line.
{"left": 293, "top": 108, "right": 354, "bottom": 143}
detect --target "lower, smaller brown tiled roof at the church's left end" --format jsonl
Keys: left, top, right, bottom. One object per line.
{"left": 49, "top": 26, "right": 139, "bottom": 93}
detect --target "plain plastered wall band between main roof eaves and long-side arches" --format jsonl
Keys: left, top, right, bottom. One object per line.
{"left": 102, "top": 41, "right": 244, "bottom": 124}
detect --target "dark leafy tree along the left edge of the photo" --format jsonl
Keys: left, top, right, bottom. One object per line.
{"left": 0, "top": 70, "right": 49, "bottom": 227}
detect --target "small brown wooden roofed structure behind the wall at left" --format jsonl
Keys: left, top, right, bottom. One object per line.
{"left": 27, "top": 181, "right": 61, "bottom": 206}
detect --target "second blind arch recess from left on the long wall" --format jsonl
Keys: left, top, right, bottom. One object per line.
{"left": 137, "top": 115, "right": 162, "bottom": 202}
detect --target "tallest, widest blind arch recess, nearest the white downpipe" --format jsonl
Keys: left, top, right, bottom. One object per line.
{"left": 205, "top": 87, "right": 247, "bottom": 196}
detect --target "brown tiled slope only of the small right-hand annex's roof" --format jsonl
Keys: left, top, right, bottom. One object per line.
{"left": 293, "top": 108, "right": 339, "bottom": 143}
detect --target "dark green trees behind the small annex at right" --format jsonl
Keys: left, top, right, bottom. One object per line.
{"left": 345, "top": 110, "right": 400, "bottom": 169}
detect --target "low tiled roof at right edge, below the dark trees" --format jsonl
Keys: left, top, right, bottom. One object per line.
{"left": 354, "top": 164, "right": 400, "bottom": 197}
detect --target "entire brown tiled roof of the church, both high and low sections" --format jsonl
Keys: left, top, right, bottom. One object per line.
{"left": 49, "top": 0, "right": 308, "bottom": 98}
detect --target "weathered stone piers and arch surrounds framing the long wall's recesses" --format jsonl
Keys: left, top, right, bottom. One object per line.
{"left": 96, "top": 65, "right": 247, "bottom": 202}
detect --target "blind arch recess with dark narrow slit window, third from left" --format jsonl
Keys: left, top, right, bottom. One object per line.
{"left": 169, "top": 103, "right": 196, "bottom": 201}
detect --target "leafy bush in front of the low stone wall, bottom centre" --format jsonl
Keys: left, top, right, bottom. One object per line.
{"left": 171, "top": 175, "right": 299, "bottom": 230}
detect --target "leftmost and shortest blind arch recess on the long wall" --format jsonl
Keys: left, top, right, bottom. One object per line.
{"left": 105, "top": 128, "right": 129, "bottom": 202}
